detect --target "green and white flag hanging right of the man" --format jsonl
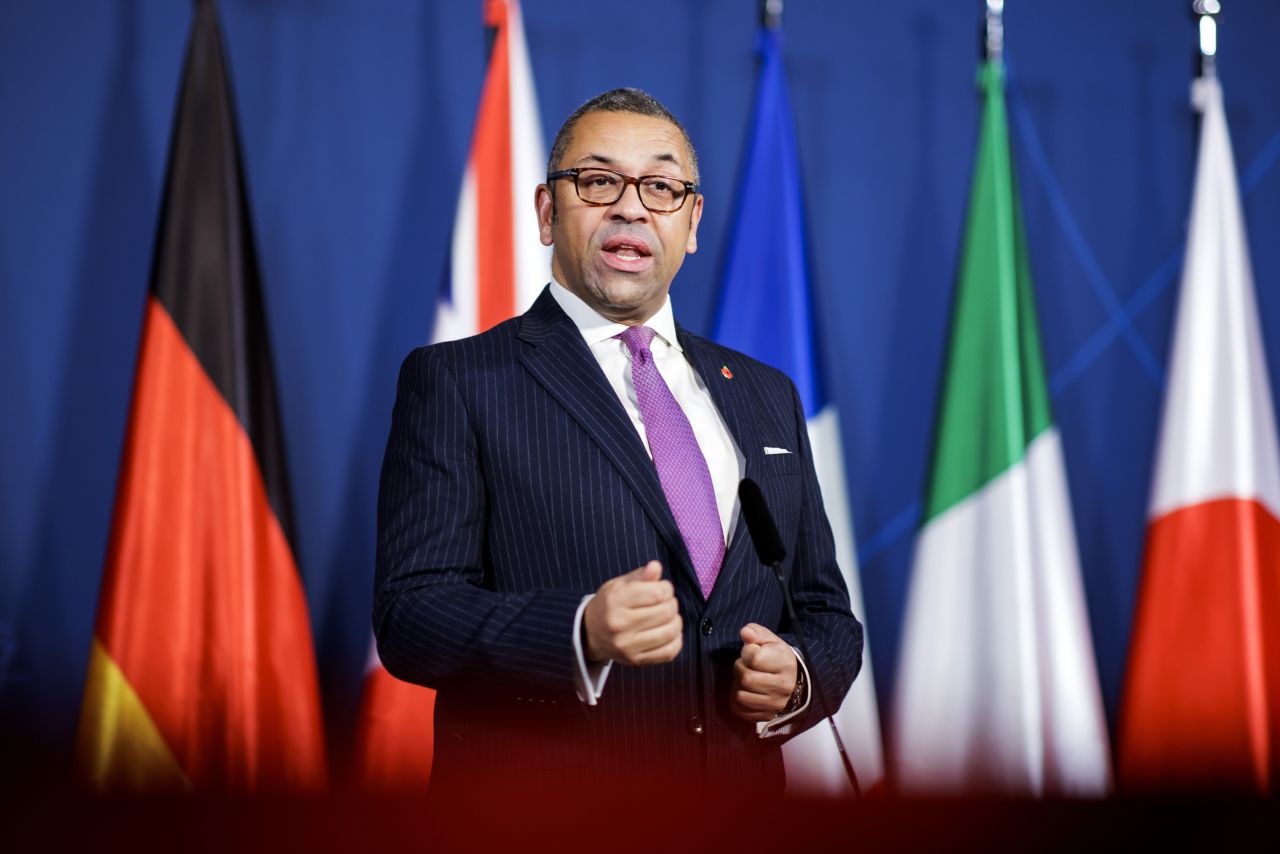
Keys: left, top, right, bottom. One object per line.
{"left": 892, "top": 60, "right": 1111, "bottom": 795}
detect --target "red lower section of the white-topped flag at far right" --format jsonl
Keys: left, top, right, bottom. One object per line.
{"left": 1119, "top": 498, "right": 1280, "bottom": 791}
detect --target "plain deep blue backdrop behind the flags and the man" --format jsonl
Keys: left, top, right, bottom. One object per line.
{"left": 0, "top": 0, "right": 1280, "bottom": 772}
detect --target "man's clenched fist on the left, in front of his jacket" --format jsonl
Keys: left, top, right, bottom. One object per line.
{"left": 582, "top": 561, "right": 685, "bottom": 665}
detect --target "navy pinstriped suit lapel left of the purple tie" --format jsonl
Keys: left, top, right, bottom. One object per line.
{"left": 518, "top": 289, "right": 696, "bottom": 584}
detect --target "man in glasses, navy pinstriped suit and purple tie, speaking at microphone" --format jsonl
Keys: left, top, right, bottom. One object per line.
{"left": 374, "top": 90, "right": 861, "bottom": 791}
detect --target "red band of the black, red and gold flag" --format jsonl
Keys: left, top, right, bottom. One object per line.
{"left": 96, "top": 298, "right": 326, "bottom": 790}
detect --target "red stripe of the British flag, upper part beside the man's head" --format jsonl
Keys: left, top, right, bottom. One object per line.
{"left": 471, "top": 1, "right": 514, "bottom": 332}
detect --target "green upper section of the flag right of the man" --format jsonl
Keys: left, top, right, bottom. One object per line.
{"left": 924, "top": 61, "right": 1053, "bottom": 522}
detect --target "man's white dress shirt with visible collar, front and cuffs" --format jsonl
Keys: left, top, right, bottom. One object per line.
{"left": 550, "top": 280, "right": 809, "bottom": 737}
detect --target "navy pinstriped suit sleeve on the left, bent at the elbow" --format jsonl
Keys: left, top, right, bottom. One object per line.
{"left": 372, "top": 347, "right": 584, "bottom": 697}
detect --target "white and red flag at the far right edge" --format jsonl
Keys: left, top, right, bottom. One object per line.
{"left": 1119, "top": 76, "right": 1280, "bottom": 793}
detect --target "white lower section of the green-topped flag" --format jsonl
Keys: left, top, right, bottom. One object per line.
{"left": 893, "top": 428, "right": 1111, "bottom": 795}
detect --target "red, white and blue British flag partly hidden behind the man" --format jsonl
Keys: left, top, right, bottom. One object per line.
{"left": 357, "top": 0, "right": 550, "bottom": 790}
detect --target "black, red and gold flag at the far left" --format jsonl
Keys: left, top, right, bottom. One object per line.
{"left": 77, "top": 0, "right": 326, "bottom": 793}
